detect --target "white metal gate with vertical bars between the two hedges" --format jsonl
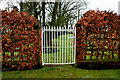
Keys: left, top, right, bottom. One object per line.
{"left": 42, "top": 26, "right": 76, "bottom": 65}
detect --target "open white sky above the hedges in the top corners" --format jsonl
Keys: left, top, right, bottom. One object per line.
{"left": 0, "top": 0, "right": 120, "bottom": 13}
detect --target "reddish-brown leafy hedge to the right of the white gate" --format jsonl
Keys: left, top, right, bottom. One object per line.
{"left": 76, "top": 10, "right": 120, "bottom": 63}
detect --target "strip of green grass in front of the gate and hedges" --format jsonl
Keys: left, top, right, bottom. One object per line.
{"left": 2, "top": 65, "right": 120, "bottom": 78}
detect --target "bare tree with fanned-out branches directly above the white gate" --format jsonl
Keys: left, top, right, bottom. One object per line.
{"left": 46, "top": 0, "right": 87, "bottom": 26}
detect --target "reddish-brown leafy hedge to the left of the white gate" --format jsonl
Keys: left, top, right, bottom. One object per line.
{"left": 2, "top": 10, "right": 41, "bottom": 69}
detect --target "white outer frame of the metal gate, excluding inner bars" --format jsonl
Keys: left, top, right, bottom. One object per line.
{"left": 41, "top": 26, "right": 76, "bottom": 66}
